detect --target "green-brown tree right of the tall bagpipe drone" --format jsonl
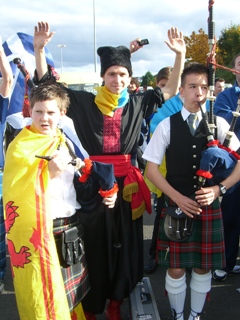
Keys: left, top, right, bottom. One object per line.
{"left": 216, "top": 24, "right": 240, "bottom": 83}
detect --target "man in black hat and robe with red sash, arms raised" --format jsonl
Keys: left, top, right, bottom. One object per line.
{"left": 34, "top": 23, "right": 185, "bottom": 320}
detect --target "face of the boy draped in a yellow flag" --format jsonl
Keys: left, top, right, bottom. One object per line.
{"left": 30, "top": 100, "right": 66, "bottom": 135}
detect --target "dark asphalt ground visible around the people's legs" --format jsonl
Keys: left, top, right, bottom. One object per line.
{"left": 0, "top": 208, "right": 240, "bottom": 320}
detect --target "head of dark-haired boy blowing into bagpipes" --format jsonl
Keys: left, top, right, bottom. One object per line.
{"left": 179, "top": 73, "right": 208, "bottom": 113}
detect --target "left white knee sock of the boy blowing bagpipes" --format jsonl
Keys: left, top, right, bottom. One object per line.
{"left": 165, "top": 272, "right": 187, "bottom": 320}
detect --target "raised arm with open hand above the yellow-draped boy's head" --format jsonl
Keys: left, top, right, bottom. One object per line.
{"left": 33, "top": 22, "right": 55, "bottom": 80}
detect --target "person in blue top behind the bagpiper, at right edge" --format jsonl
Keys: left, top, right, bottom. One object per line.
{"left": 213, "top": 54, "right": 240, "bottom": 281}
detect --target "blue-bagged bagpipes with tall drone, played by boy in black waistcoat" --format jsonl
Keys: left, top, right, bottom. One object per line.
{"left": 196, "top": 0, "right": 240, "bottom": 194}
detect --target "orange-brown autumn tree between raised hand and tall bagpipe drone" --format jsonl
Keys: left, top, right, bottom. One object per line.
{"left": 184, "top": 29, "right": 209, "bottom": 64}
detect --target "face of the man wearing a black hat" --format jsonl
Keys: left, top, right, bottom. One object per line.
{"left": 103, "top": 66, "right": 131, "bottom": 94}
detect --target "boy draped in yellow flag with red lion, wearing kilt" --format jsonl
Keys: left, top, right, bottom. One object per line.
{"left": 3, "top": 84, "right": 87, "bottom": 320}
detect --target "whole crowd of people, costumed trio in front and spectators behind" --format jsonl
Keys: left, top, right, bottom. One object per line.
{"left": 0, "top": 22, "right": 240, "bottom": 320}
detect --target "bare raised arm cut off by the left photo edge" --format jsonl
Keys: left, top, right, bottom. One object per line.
{"left": 0, "top": 37, "right": 13, "bottom": 97}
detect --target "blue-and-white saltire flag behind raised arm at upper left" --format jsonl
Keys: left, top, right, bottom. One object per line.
{"left": 3, "top": 32, "right": 54, "bottom": 116}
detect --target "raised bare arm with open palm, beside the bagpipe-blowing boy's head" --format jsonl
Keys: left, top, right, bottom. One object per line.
{"left": 162, "top": 27, "right": 186, "bottom": 100}
